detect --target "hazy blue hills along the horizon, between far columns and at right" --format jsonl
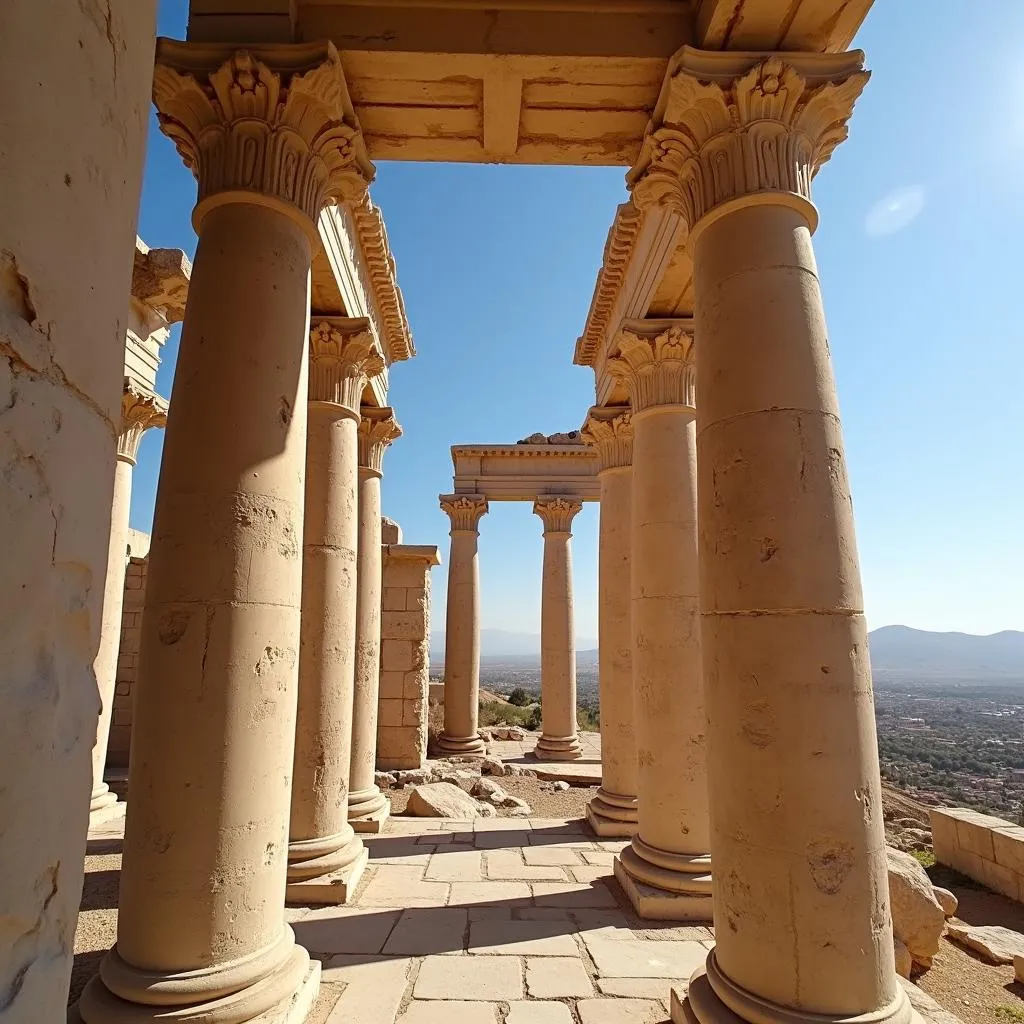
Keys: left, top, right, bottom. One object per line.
{"left": 430, "top": 626, "right": 1024, "bottom": 684}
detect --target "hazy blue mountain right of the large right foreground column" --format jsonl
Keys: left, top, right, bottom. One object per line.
{"left": 868, "top": 626, "right": 1024, "bottom": 683}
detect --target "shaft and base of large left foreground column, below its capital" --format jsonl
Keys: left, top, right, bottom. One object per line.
{"left": 83, "top": 204, "right": 310, "bottom": 1022}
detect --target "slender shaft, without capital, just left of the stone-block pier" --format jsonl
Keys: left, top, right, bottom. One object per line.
{"left": 348, "top": 467, "right": 387, "bottom": 818}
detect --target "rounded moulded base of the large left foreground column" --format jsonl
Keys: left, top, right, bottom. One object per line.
{"left": 78, "top": 929, "right": 321, "bottom": 1024}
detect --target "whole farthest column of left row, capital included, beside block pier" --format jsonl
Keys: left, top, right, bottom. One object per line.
{"left": 348, "top": 408, "right": 401, "bottom": 833}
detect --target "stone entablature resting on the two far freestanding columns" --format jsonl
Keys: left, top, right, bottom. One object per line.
{"left": 452, "top": 441, "right": 600, "bottom": 502}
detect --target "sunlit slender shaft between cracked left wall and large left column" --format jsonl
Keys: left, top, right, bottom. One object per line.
{"left": 89, "top": 455, "right": 135, "bottom": 819}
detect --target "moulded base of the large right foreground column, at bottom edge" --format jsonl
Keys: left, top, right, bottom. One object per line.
{"left": 670, "top": 950, "right": 924, "bottom": 1024}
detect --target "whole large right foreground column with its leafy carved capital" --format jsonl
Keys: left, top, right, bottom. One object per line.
{"left": 631, "top": 51, "right": 916, "bottom": 1024}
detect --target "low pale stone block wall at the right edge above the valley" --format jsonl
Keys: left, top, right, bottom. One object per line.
{"left": 931, "top": 807, "right": 1024, "bottom": 902}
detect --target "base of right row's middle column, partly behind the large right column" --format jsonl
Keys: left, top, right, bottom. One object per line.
{"left": 614, "top": 836, "right": 712, "bottom": 924}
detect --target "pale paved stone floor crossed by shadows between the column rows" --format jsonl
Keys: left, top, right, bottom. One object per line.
{"left": 79, "top": 818, "right": 712, "bottom": 1024}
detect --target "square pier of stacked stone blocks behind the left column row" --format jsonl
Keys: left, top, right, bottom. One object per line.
{"left": 377, "top": 524, "right": 440, "bottom": 771}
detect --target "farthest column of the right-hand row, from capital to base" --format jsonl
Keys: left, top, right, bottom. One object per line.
{"left": 582, "top": 407, "right": 637, "bottom": 836}
